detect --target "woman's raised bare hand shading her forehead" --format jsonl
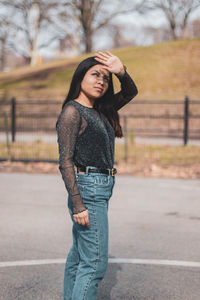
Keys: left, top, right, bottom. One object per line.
{"left": 95, "top": 51, "right": 125, "bottom": 75}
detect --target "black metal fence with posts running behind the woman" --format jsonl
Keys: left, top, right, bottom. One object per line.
{"left": 0, "top": 96, "right": 200, "bottom": 162}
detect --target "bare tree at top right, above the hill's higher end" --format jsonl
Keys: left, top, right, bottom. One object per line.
{"left": 145, "top": 0, "right": 200, "bottom": 40}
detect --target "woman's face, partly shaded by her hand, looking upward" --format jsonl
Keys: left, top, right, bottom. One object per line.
{"left": 81, "top": 64, "right": 109, "bottom": 99}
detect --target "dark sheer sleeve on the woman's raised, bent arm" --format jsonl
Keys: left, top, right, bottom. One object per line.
{"left": 114, "top": 66, "right": 138, "bottom": 110}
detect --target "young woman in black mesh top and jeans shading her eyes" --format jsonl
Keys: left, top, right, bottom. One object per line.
{"left": 56, "top": 51, "right": 138, "bottom": 300}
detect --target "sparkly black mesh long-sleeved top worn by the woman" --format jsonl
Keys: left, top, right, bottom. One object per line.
{"left": 56, "top": 70, "right": 138, "bottom": 213}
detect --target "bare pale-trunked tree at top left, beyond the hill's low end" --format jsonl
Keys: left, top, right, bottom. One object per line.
{"left": 1, "top": 0, "right": 67, "bottom": 65}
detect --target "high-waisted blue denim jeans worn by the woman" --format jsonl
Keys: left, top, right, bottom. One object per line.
{"left": 63, "top": 173, "right": 115, "bottom": 300}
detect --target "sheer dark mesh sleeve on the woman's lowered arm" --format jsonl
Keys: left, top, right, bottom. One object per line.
{"left": 56, "top": 105, "right": 87, "bottom": 214}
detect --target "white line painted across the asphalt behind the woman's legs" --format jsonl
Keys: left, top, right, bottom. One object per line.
{"left": 0, "top": 258, "right": 200, "bottom": 268}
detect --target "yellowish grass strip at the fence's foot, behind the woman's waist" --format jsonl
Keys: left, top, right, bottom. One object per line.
{"left": 0, "top": 140, "right": 200, "bottom": 166}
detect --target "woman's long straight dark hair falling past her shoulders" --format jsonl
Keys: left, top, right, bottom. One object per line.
{"left": 62, "top": 56, "right": 123, "bottom": 137}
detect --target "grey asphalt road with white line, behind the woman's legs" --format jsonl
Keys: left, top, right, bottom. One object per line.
{"left": 0, "top": 173, "right": 200, "bottom": 300}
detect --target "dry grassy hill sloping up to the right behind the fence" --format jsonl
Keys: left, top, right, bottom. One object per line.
{"left": 0, "top": 38, "right": 200, "bottom": 101}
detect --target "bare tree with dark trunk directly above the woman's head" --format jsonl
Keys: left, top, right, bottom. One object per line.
{"left": 61, "top": 0, "right": 146, "bottom": 53}
